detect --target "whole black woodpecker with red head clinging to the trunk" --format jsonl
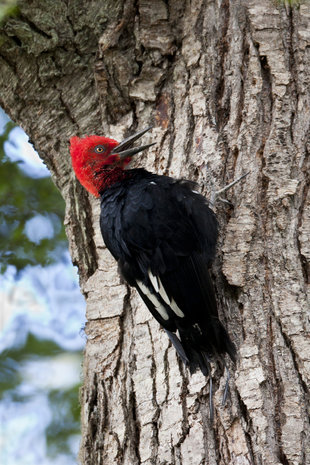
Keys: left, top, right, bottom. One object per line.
{"left": 70, "top": 128, "right": 236, "bottom": 391}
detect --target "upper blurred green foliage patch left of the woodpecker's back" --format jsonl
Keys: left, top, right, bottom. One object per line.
{"left": 0, "top": 123, "right": 67, "bottom": 273}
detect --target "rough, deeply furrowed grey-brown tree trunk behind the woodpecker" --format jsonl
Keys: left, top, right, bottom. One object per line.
{"left": 0, "top": 0, "right": 310, "bottom": 465}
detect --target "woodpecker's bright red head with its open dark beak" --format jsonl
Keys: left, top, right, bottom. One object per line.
{"left": 70, "top": 128, "right": 153, "bottom": 197}
